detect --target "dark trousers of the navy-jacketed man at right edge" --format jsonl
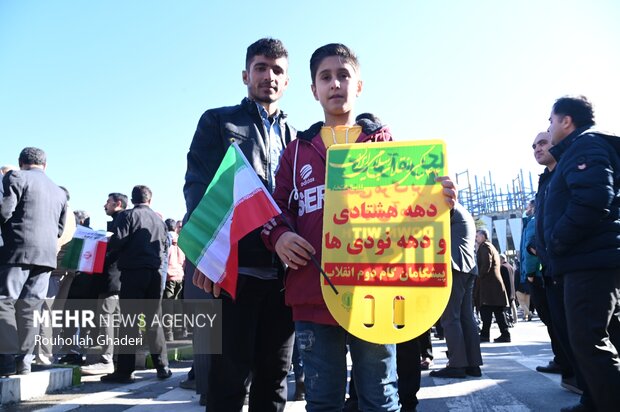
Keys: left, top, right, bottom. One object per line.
{"left": 564, "top": 269, "right": 620, "bottom": 411}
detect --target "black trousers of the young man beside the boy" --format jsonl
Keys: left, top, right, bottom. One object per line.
{"left": 207, "top": 275, "right": 294, "bottom": 412}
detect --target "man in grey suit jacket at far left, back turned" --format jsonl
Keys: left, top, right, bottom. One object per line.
{"left": 0, "top": 147, "right": 67, "bottom": 375}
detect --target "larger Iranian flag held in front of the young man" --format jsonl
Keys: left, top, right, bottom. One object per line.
{"left": 178, "top": 143, "right": 282, "bottom": 299}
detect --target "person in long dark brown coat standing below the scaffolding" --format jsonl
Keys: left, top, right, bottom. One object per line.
{"left": 476, "top": 229, "right": 510, "bottom": 342}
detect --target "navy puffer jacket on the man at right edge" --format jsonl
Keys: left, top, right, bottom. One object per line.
{"left": 542, "top": 128, "right": 620, "bottom": 276}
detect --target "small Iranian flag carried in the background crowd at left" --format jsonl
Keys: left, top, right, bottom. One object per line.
{"left": 60, "top": 225, "right": 108, "bottom": 273}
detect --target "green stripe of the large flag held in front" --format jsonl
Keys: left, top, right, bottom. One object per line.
{"left": 179, "top": 145, "right": 245, "bottom": 264}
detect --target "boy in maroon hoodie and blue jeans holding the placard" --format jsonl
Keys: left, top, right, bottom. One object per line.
{"left": 263, "top": 44, "right": 400, "bottom": 411}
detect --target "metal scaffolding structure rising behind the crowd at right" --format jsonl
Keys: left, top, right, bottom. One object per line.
{"left": 456, "top": 169, "right": 536, "bottom": 217}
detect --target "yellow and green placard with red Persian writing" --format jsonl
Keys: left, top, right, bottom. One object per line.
{"left": 321, "top": 140, "right": 452, "bottom": 343}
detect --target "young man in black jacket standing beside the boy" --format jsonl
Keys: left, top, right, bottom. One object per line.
{"left": 183, "top": 39, "right": 296, "bottom": 412}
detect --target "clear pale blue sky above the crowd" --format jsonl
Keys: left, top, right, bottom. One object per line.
{"left": 0, "top": 0, "right": 620, "bottom": 229}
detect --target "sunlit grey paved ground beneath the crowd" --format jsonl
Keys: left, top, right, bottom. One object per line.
{"left": 0, "top": 320, "right": 579, "bottom": 412}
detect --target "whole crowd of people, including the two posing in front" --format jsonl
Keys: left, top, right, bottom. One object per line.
{"left": 0, "top": 38, "right": 620, "bottom": 412}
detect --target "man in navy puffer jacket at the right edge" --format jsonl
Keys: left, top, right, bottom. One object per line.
{"left": 539, "top": 96, "right": 620, "bottom": 411}
